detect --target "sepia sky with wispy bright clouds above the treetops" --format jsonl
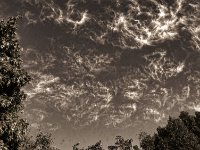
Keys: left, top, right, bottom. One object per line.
{"left": 0, "top": 0, "right": 200, "bottom": 150}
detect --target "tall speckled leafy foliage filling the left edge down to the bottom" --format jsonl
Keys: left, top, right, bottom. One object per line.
{"left": 0, "top": 17, "right": 57, "bottom": 150}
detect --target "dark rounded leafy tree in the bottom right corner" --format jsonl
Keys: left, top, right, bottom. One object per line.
{"left": 140, "top": 112, "right": 200, "bottom": 150}
